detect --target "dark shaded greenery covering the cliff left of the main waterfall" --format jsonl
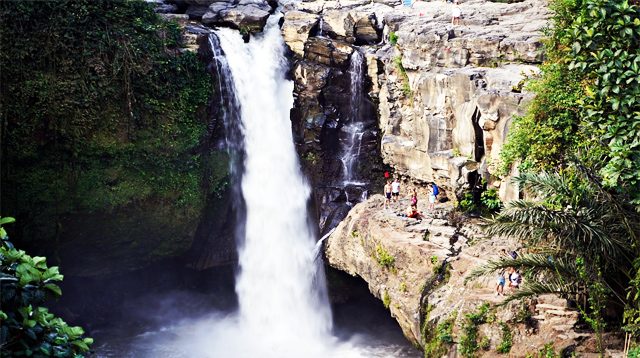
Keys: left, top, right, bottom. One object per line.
{"left": 0, "top": 0, "right": 217, "bottom": 243}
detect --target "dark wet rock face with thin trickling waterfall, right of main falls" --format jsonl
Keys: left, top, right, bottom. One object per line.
{"left": 282, "top": 10, "right": 382, "bottom": 231}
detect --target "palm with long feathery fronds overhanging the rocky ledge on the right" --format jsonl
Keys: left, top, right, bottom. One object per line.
{"left": 467, "top": 168, "right": 640, "bottom": 338}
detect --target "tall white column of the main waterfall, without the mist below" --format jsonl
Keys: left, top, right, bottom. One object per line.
{"left": 218, "top": 19, "right": 331, "bottom": 354}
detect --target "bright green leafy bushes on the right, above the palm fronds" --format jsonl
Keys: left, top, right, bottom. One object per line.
{"left": 501, "top": 0, "right": 640, "bottom": 210}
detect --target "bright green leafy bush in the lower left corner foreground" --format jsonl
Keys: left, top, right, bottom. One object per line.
{"left": 0, "top": 218, "right": 93, "bottom": 357}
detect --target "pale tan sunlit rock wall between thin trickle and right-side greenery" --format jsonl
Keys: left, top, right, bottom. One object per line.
{"left": 377, "top": 0, "right": 548, "bottom": 200}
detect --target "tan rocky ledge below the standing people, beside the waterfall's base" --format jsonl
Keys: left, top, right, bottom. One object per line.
{"left": 325, "top": 195, "right": 616, "bottom": 357}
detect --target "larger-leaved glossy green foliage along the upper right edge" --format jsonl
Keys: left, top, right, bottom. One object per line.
{"left": 560, "top": 0, "right": 640, "bottom": 207}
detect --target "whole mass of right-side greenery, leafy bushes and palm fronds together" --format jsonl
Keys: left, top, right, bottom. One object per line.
{"left": 475, "top": 0, "right": 640, "bottom": 354}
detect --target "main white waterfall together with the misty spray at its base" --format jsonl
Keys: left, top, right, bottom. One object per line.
{"left": 85, "top": 16, "right": 415, "bottom": 358}
